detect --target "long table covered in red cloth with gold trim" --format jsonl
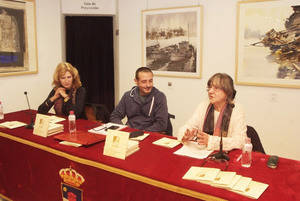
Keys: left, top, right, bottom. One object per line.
{"left": 0, "top": 110, "right": 300, "bottom": 201}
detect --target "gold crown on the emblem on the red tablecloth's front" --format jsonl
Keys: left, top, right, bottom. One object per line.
{"left": 59, "top": 168, "right": 84, "bottom": 187}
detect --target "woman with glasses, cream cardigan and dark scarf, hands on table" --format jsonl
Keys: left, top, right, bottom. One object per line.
{"left": 177, "top": 73, "right": 247, "bottom": 151}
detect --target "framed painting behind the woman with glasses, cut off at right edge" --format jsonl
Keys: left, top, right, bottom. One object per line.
{"left": 235, "top": 1, "right": 300, "bottom": 88}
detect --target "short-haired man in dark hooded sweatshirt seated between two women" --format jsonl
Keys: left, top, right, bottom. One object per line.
{"left": 110, "top": 67, "right": 168, "bottom": 132}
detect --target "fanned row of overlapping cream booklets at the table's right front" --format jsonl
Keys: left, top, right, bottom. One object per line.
{"left": 183, "top": 166, "right": 269, "bottom": 199}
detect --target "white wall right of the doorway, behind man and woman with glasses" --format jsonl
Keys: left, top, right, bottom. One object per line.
{"left": 116, "top": 0, "right": 300, "bottom": 160}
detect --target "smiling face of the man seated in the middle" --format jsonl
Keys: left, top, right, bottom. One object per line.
{"left": 134, "top": 72, "right": 153, "bottom": 96}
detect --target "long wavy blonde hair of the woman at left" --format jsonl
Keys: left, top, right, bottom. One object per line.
{"left": 52, "top": 62, "right": 82, "bottom": 89}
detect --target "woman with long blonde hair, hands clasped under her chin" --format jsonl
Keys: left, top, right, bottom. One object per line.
{"left": 38, "top": 62, "right": 86, "bottom": 118}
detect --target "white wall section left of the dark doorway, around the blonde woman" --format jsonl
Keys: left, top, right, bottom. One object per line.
{"left": 0, "top": 0, "right": 62, "bottom": 113}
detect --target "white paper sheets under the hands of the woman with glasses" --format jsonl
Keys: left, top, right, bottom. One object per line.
{"left": 174, "top": 142, "right": 212, "bottom": 159}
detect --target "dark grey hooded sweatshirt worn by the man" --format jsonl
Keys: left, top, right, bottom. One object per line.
{"left": 110, "top": 87, "right": 168, "bottom": 132}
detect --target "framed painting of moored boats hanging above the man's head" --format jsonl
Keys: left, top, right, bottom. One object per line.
{"left": 142, "top": 6, "right": 203, "bottom": 78}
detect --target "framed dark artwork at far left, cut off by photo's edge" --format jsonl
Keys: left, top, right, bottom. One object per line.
{"left": 0, "top": 0, "right": 38, "bottom": 76}
